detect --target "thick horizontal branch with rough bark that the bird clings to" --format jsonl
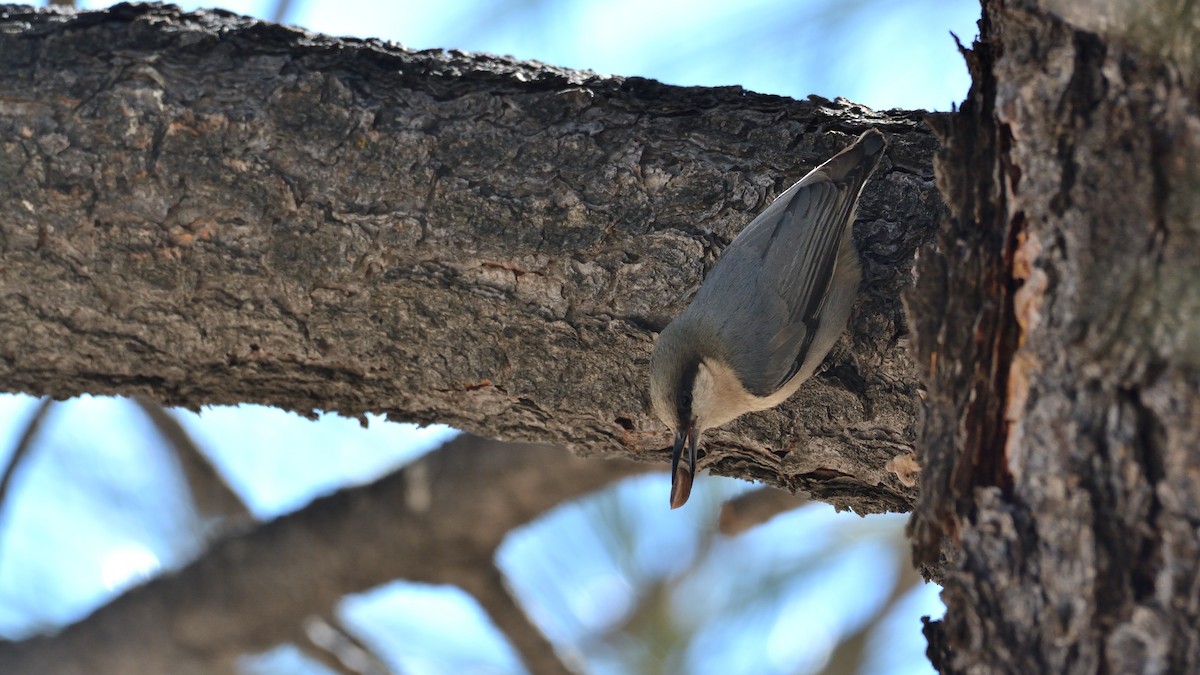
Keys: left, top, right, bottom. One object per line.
{"left": 0, "top": 5, "right": 941, "bottom": 513}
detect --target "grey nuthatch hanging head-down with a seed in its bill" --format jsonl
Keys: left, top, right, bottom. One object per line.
{"left": 650, "top": 129, "right": 887, "bottom": 509}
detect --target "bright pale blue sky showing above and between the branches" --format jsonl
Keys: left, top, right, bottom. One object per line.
{"left": 0, "top": 0, "right": 979, "bottom": 674}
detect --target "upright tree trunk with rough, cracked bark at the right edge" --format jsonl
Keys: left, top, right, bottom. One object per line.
{"left": 908, "top": 0, "right": 1200, "bottom": 674}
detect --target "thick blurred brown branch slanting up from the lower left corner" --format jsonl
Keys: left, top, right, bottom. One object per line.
{"left": 0, "top": 436, "right": 647, "bottom": 675}
